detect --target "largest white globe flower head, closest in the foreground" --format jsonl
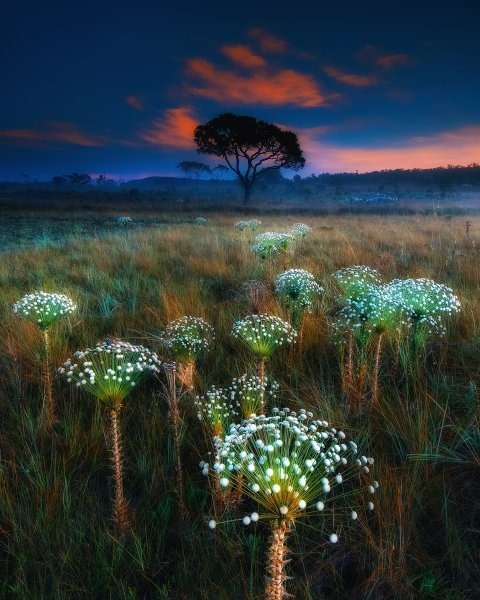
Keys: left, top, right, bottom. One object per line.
{"left": 202, "top": 408, "right": 378, "bottom": 541}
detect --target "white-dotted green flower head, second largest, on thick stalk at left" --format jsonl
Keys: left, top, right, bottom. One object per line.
{"left": 59, "top": 339, "right": 161, "bottom": 408}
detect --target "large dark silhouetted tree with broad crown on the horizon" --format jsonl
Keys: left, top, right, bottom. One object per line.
{"left": 193, "top": 113, "right": 305, "bottom": 204}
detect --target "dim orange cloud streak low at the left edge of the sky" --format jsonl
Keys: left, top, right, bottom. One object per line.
{"left": 0, "top": 121, "right": 106, "bottom": 146}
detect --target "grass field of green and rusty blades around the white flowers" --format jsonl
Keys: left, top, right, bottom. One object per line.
{"left": 0, "top": 214, "right": 480, "bottom": 600}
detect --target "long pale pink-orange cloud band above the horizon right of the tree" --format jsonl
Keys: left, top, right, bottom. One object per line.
{"left": 297, "top": 125, "right": 480, "bottom": 173}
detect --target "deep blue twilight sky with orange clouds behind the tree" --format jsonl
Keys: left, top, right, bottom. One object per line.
{"left": 0, "top": 0, "right": 480, "bottom": 181}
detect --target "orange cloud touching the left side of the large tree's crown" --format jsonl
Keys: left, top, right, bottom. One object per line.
{"left": 140, "top": 106, "right": 199, "bottom": 149}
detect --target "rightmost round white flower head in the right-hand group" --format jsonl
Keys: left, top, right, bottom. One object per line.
{"left": 385, "top": 278, "right": 460, "bottom": 333}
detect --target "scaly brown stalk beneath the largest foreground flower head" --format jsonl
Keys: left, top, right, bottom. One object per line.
{"left": 265, "top": 521, "right": 291, "bottom": 600}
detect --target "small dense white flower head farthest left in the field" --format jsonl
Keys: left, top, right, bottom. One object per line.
{"left": 13, "top": 292, "right": 77, "bottom": 330}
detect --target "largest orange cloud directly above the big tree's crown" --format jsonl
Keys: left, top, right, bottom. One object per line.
{"left": 187, "top": 58, "right": 327, "bottom": 108}
